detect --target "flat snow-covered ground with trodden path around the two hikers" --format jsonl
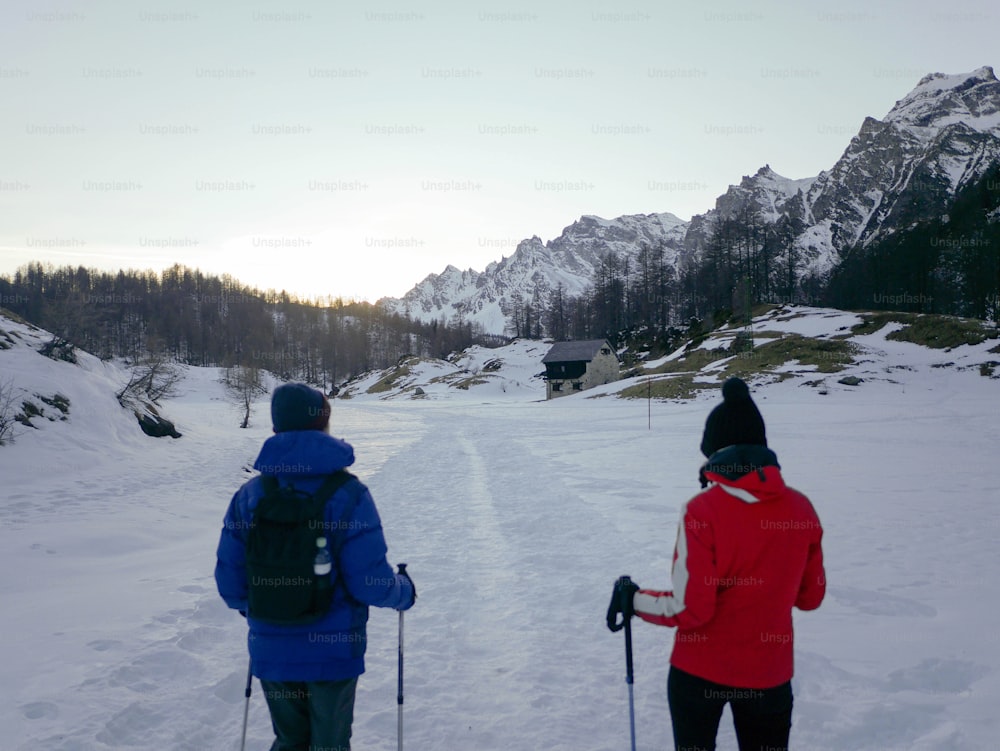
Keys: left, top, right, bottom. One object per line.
{"left": 0, "top": 310, "right": 1000, "bottom": 751}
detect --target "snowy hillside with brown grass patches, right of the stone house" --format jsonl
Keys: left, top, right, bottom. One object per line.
{"left": 616, "top": 306, "right": 1000, "bottom": 398}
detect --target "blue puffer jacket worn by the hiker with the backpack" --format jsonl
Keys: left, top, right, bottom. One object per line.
{"left": 215, "top": 430, "right": 413, "bottom": 681}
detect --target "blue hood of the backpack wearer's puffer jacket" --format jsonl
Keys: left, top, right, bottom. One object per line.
{"left": 253, "top": 430, "right": 354, "bottom": 477}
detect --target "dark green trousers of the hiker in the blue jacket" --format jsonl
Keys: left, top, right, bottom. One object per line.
{"left": 260, "top": 678, "right": 358, "bottom": 751}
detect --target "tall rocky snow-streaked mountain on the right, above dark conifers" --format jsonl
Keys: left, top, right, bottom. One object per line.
{"left": 684, "top": 67, "right": 1000, "bottom": 276}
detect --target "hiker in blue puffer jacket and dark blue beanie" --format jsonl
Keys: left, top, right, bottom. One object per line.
{"left": 215, "top": 383, "right": 416, "bottom": 751}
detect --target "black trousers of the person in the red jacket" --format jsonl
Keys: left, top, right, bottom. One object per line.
{"left": 667, "top": 667, "right": 792, "bottom": 751}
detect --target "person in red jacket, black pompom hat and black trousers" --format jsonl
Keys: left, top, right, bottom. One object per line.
{"left": 632, "top": 378, "right": 826, "bottom": 751}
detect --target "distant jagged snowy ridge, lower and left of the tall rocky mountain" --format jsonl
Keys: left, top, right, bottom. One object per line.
{"left": 381, "top": 213, "right": 688, "bottom": 334}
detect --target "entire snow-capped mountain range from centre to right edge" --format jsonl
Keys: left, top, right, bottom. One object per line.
{"left": 382, "top": 66, "right": 1000, "bottom": 333}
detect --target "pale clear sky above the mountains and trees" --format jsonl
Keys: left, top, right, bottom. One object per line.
{"left": 0, "top": 0, "right": 1000, "bottom": 300}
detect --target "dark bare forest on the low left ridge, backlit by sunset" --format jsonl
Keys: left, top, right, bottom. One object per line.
{"left": 0, "top": 263, "right": 485, "bottom": 387}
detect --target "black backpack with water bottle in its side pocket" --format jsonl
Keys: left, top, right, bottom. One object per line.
{"left": 246, "top": 470, "right": 359, "bottom": 626}
